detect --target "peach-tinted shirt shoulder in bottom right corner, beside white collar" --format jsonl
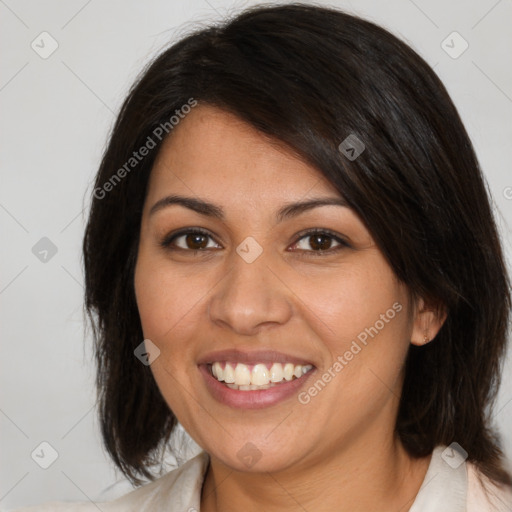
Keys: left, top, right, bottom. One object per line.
{"left": 467, "top": 462, "right": 512, "bottom": 512}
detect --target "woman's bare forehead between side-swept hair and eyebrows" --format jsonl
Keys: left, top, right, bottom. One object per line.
{"left": 148, "top": 105, "right": 339, "bottom": 201}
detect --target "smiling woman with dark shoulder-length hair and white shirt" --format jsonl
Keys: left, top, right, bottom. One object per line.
{"left": 15, "top": 4, "right": 512, "bottom": 512}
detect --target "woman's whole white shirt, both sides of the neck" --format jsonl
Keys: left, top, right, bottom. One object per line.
{"left": 10, "top": 446, "right": 512, "bottom": 512}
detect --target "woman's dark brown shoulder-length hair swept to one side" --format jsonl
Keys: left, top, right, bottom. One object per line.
{"left": 83, "top": 4, "right": 512, "bottom": 485}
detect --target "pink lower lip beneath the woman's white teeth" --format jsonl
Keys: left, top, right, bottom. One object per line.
{"left": 199, "top": 364, "right": 315, "bottom": 409}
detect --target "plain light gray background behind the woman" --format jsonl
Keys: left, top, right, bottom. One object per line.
{"left": 0, "top": 0, "right": 512, "bottom": 510}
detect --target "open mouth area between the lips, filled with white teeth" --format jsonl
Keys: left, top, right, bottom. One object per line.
{"left": 207, "top": 361, "right": 314, "bottom": 391}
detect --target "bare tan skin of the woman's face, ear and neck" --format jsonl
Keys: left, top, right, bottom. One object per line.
{"left": 135, "top": 105, "right": 444, "bottom": 512}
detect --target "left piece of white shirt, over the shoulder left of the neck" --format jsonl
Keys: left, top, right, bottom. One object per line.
{"left": 8, "top": 451, "right": 209, "bottom": 512}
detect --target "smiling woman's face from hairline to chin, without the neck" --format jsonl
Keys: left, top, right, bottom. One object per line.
{"left": 135, "top": 105, "right": 426, "bottom": 471}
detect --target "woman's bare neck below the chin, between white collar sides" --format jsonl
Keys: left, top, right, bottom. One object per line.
{"left": 201, "top": 436, "right": 430, "bottom": 512}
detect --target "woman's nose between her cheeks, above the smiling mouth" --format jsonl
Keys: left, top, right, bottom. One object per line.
{"left": 208, "top": 244, "right": 293, "bottom": 336}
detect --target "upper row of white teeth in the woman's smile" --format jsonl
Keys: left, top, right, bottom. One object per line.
{"left": 212, "top": 362, "right": 313, "bottom": 386}
